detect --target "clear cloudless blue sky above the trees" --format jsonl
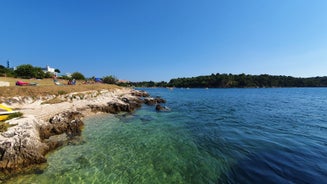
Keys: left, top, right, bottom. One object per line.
{"left": 0, "top": 0, "right": 327, "bottom": 81}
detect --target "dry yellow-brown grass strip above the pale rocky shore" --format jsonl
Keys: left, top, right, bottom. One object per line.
{"left": 0, "top": 77, "right": 121, "bottom": 97}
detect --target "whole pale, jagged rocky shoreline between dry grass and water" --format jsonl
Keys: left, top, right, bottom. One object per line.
{"left": 0, "top": 88, "right": 165, "bottom": 180}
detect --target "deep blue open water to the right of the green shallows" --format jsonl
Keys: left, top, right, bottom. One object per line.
{"left": 147, "top": 88, "right": 327, "bottom": 183}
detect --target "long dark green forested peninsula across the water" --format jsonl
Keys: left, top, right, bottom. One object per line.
{"left": 128, "top": 73, "right": 327, "bottom": 88}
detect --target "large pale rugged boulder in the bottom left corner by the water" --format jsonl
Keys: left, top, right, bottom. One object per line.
{"left": 0, "top": 117, "right": 49, "bottom": 178}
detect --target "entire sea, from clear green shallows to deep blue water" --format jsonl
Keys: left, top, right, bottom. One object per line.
{"left": 7, "top": 88, "right": 327, "bottom": 184}
